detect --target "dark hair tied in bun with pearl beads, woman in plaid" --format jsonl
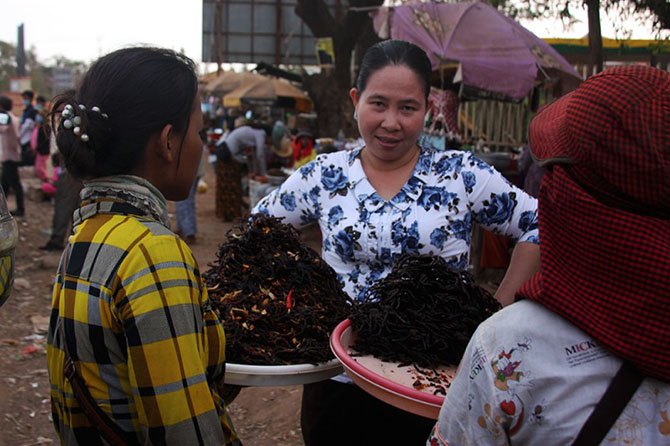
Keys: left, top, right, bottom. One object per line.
{"left": 51, "top": 47, "right": 198, "bottom": 178}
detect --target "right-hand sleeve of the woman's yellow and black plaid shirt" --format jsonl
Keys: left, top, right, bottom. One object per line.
{"left": 115, "top": 237, "right": 240, "bottom": 444}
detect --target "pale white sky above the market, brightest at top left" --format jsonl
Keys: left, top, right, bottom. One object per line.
{"left": 0, "top": 0, "right": 653, "bottom": 69}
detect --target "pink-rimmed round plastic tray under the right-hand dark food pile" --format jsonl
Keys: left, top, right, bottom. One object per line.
{"left": 330, "top": 319, "right": 456, "bottom": 420}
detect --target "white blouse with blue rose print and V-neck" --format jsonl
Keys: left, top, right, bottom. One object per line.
{"left": 253, "top": 147, "right": 539, "bottom": 299}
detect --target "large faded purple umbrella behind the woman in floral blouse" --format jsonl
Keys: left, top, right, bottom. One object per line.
{"left": 373, "top": 2, "right": 579, "bottom": 100}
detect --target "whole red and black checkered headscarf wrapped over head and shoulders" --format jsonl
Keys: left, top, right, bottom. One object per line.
{"left": 517, "top": 66, "right": 670, "bottom": 382}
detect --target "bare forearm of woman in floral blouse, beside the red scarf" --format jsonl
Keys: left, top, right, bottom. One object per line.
{"left": 495, "top": 242, "right": 540, "bottom": 307}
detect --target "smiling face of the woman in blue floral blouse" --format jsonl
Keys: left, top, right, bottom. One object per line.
{"left": 350, "top": 65, "right": 427, "bottom": 166}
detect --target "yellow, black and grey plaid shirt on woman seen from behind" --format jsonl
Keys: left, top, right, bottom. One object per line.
{"left": 47, "top": 182, "right": 240, "bottom": 446}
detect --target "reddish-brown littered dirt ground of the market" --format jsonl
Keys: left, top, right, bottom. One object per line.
{"left": 0, "top": 166, "right": 303, "bottom": 446}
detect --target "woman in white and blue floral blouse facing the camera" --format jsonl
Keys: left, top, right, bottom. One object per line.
{"left": 255, "top": 41, "right": 539, "bottom": 446}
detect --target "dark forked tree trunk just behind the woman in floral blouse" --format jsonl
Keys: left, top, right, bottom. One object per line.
{"left": 296, "top": 0, "right": 383, "bottom": 137}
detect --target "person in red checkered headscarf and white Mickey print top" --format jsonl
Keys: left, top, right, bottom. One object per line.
{"left": 428, "top": 66, "right": 670, "bottom": 446}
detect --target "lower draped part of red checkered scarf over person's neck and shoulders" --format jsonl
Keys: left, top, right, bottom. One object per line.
{"left": 517, "top": 166, "right": 670, "bottom": 382}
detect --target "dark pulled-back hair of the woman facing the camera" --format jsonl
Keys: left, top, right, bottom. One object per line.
{"left": 356, "top": 40, "right": 433, "bottom": 101}
